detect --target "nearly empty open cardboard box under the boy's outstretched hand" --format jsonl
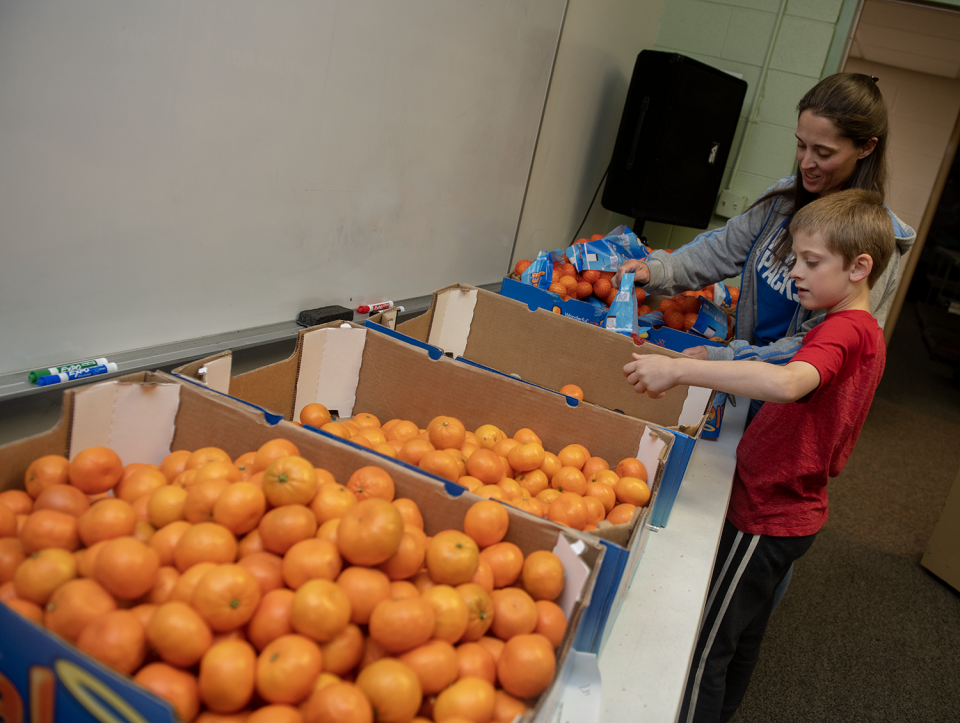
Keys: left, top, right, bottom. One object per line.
{"left": 367, "top": 284, "right": 714, "bottom": 527}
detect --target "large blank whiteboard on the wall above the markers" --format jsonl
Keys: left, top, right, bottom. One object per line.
{"left": 0, "top": 0, "right": 566, "bottom": 373}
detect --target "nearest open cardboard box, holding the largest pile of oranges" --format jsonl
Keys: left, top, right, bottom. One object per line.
{"left": 0, "top": 373, "right": 607, "bottom": 723}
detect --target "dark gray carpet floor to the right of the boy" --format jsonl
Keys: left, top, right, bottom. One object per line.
{"left": 733, "top": 305, "right": 960, "bottom": 723}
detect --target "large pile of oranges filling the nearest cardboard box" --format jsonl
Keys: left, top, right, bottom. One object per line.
{"left": 0, "top": 442, "right": 566, "bottom": 723}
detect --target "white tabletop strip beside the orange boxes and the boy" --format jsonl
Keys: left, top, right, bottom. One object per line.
{"left": 598, "top": 399, "right": 749, "bottom": 723}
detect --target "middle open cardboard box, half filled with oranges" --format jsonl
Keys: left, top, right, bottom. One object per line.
{"left": 174, "top": 322, "right": 675, "bottom": 652}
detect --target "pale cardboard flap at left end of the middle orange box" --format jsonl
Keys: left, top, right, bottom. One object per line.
{"left": 293, "top": 326, "right": 367, "bottom": 419}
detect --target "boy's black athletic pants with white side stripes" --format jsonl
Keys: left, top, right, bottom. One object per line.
{"left": 680, "top": 521, "right": 816, "bottom": 723}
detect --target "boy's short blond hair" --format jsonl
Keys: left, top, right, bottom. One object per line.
{"left": 790, "top": 188, "right": 896, "bottom": 289}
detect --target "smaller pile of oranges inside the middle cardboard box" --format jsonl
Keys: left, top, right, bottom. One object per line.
{"left": 300, "top": 410, "right": 650, "bottom": 532}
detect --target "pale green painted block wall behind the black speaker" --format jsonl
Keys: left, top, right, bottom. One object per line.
{"left": 632, "top": 0, "right": 848, "bottom": 248}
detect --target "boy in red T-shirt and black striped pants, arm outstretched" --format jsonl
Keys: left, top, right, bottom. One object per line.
{"left": 623, "top": 189, "right": 894, "bottom": 723}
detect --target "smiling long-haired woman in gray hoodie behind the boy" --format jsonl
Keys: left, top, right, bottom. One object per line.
{"left": 613, "top": 73, "right": 916, "bottom": 368}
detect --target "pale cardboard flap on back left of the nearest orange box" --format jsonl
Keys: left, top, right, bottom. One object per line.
{"left": 68, "top": 382, "right": 181, "bottom": 465}
